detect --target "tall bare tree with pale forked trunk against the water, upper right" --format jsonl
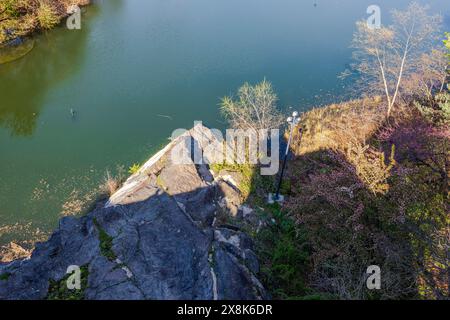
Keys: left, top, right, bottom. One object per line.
{"left": 352, "top": 2, "right": 442, "bottom": 117}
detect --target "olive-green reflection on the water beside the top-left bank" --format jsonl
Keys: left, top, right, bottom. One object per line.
{"left": 0, "top": 7, "right": 95, "bottom": 136}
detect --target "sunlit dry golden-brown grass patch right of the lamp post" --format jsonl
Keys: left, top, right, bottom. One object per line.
{"left": 293, "top": 97, "right": 406, "bottom": 193}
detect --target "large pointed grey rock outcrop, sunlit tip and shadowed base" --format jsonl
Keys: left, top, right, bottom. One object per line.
{"left": 0, "top": 125, "right": 266, "bottom": 299}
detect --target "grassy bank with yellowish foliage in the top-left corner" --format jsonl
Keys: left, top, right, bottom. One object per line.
{"left": 0, "top": 0, "right": 90, "bottom": 45}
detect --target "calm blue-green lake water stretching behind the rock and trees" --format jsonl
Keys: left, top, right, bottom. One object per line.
{"left": 0, "top": 0, "right": 450, "bottom": 241}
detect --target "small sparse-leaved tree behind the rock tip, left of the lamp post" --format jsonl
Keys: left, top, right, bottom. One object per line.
{"left": 220, "top": 79, "right": 283, "bottom": 132}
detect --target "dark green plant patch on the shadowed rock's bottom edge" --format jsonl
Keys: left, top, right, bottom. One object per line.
{"left": 46, "top": 265, "right": 89, "bottom": 300}
